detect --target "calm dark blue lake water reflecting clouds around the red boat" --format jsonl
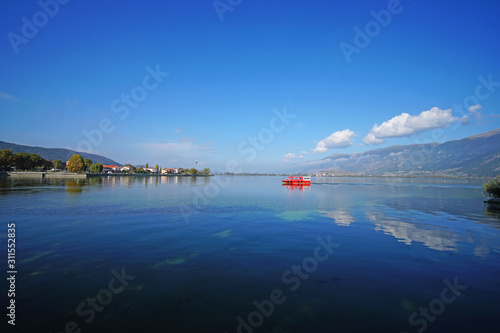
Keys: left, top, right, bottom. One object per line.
{"left": 0, "top": 176, "right": 500, "bottom": 333}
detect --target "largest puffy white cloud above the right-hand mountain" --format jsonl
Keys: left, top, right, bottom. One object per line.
{"left": 363, "top": 107, "right": 458, "bottom": 144}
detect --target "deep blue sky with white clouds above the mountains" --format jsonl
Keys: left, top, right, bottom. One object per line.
{"left": 0, "top": 0, "right": 500, "bottom": 171}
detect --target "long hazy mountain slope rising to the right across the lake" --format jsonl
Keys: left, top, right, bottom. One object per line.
{"left": 289, "top": 129, "right": 500, "bottom": 176}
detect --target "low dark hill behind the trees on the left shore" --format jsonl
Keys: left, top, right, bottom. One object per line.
{"left": 0, "top": 141, "right": 121, "bottom": 166}
